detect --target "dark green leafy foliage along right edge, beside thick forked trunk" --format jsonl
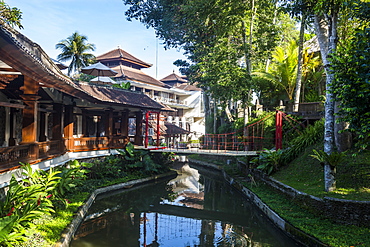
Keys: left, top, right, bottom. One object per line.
{"left": 332, "top": 6, "right": 370, "bottom": 150}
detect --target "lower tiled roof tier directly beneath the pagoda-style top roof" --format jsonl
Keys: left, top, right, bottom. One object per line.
{"left": 111, "top": 65, "right": 167, "bottom": 87}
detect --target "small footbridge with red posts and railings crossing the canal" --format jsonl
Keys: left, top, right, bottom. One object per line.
{"left": 143, "top": 110, "right": 305, "bottom": 156}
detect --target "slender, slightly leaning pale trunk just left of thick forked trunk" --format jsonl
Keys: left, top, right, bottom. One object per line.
{"left": 293, "top": 14, "right": 306, "bottom": 112}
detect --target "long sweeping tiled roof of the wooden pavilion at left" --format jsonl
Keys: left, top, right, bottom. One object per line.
{"left": 0, "top": 25, "right": 168, "bottom": 111}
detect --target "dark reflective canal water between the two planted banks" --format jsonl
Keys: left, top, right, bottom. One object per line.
{"left": 70, "top": 159, "right": 300, "bottom": 247}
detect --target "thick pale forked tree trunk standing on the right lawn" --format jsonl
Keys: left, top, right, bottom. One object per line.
{"left": 314, "top": 12, "right": 338, "bottom": 191}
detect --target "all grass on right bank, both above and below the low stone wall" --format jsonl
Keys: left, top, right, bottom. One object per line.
{"left": 192, "top": 144, "right": 370, "bottom": 247}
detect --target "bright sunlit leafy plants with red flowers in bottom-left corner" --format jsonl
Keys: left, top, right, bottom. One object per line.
{"left": 0, "top": 161, "right": 94, "bottom": 246}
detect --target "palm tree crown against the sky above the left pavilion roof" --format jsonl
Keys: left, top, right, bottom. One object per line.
{"left": 55, "top": 31, "right": 95, "bottom": 75}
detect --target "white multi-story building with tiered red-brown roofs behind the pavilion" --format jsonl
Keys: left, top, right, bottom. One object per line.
{"left": 97, "top": 47, "right": 205, "bottom": 144}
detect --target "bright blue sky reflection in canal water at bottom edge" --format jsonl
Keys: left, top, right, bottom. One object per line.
{"left": 140, "top": 213, "right": 253, "bottom": 247}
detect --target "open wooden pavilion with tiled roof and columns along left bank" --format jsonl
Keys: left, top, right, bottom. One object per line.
{"left": 0, "top": 25, "right": 163, "bottom": 179}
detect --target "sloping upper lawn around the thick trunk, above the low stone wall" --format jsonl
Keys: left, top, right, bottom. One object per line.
{"left": 272, "top": 145, "right": 370, "bottom": 201}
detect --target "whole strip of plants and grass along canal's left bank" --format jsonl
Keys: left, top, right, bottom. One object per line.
{"left": 0, "top": 144, "right": 173, "bottom": 247}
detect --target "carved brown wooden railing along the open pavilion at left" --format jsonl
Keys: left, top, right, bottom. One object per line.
{"left": 0, "top": 136, "right": 128, "bottom": 172}
